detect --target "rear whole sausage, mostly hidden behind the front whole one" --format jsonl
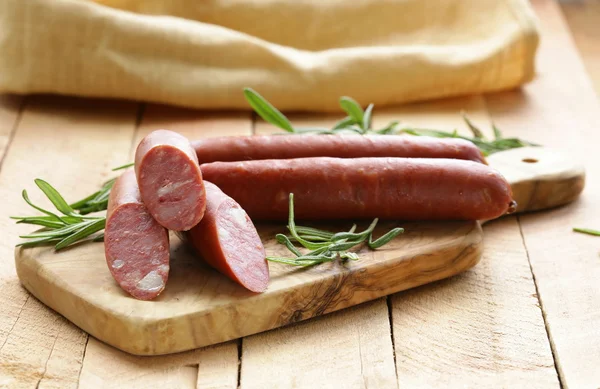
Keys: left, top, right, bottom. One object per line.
{"left": 192, "top": 135, "right": 486, "bottom": 164}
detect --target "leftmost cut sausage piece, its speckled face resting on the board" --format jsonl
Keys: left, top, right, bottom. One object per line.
{"left": 104, "top": 169, "right": 169, "bottom": 300}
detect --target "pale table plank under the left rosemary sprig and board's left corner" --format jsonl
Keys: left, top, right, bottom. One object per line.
{"left": 0, "top": 97, "right": 136, "bottom": 388}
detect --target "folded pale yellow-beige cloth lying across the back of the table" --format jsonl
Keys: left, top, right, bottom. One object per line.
{"left": 0, "top": 0, "right": 539, "bottom": 111}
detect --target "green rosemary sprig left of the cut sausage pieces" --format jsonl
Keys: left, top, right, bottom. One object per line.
{"left": 11, "top": 178, "right": 106, "bottom": 250}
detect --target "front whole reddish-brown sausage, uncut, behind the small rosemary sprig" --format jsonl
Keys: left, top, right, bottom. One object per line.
{"left": 201, "top": 157, "right": 516, "bottom": 220}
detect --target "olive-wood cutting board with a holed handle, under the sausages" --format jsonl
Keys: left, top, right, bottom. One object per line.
{"left": 15, "top": 148, "right": 585, "bottom": 355}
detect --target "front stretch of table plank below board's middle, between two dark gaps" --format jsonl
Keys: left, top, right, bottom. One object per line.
{"left": 240, "top": 298, "right": 398, "bottom": 389}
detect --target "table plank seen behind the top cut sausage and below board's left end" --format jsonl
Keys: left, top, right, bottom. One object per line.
{"left": 80, "top": 104, "right": 252, "bottom": 389}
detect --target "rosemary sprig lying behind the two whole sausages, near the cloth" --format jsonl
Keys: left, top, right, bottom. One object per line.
{"left": 244, "top": 88, "right": 539, "bottom": 156}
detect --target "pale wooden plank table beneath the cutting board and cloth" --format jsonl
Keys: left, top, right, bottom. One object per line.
{"left": 0, "top": 0, "right": 600, "bottom": 388}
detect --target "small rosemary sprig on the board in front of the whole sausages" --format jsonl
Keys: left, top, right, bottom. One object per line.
{"left": 267, "top": 193, "right": 404, "bottom": 266}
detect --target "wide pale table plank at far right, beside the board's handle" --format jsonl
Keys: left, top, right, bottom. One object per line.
{"left": 486, "top": 0, "right": 600, "bottom": 388}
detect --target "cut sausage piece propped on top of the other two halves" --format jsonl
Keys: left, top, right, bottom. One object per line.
{"left": 135, "top": 130, "right": 206, "bottom": 231}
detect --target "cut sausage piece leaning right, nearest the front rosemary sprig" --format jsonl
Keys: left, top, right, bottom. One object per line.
{"left": 180, "top": 181, "right": 269, "bottom": 292}
